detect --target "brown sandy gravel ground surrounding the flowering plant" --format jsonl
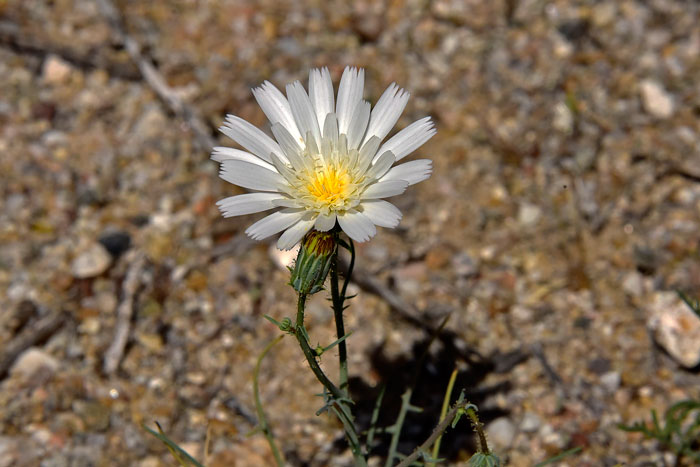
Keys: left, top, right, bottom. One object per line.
{"left": 0, "top": 0, "right": 700, "bottom": 467}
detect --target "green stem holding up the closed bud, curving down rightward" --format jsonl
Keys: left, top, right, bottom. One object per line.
{"left": 294, "top": 294, "right": 367, "bottom": 467}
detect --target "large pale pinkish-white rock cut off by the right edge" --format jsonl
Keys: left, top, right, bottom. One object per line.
{"left": 648, "top": 292, "right": 700, "bottom": 368}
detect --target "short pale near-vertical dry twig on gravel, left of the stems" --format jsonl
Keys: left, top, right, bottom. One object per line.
{"left": 102, "top": 255, "right": 145, "bottom": 375}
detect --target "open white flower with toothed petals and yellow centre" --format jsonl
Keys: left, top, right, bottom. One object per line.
{"left": 211, "top": 67, "right": 435, "bottom": 250}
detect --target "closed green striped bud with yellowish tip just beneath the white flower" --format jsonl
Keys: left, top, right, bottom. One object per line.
{"left": 289, "top": 230, "right": 338, "bottom": 295}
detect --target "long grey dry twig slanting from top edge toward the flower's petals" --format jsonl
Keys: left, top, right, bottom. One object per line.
{"left": 97, "top": 0, "right": 216, "bottom": 151}
